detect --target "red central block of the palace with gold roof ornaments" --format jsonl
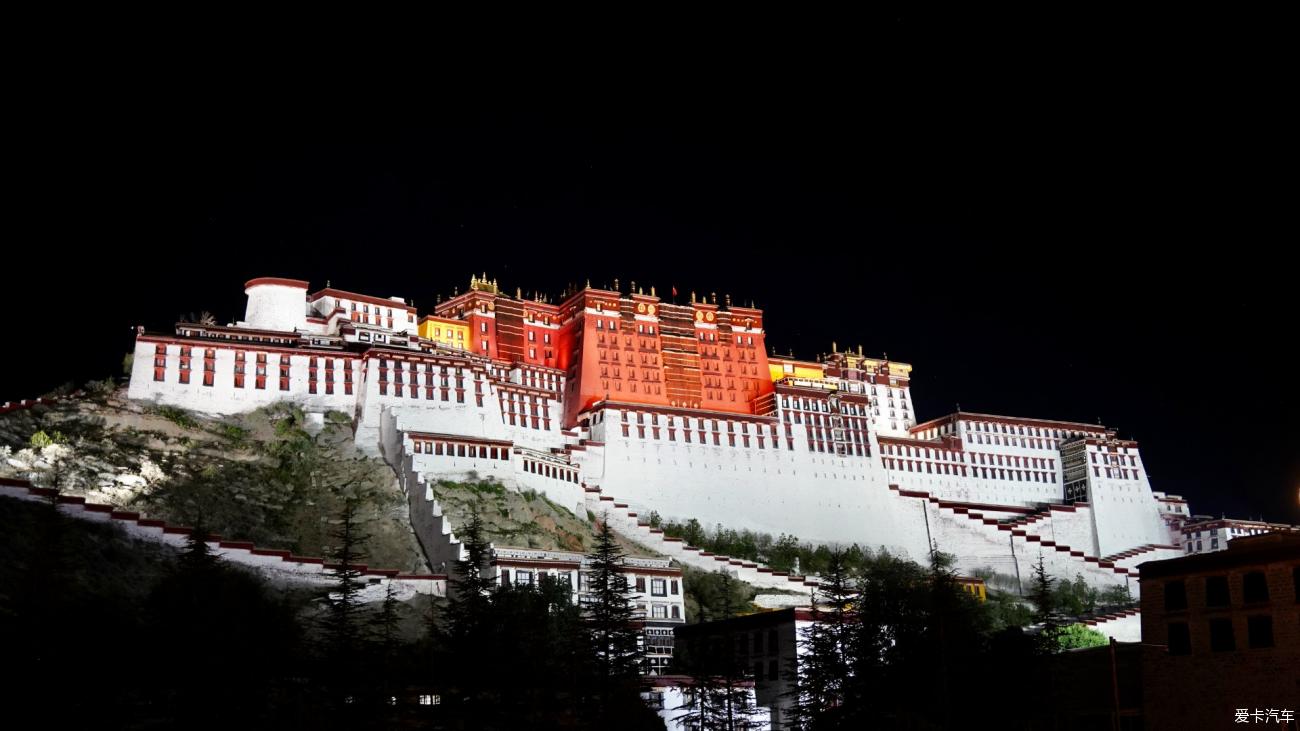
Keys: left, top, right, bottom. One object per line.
{"left": 434, "top": 280, "right": 774, "bottom": 427}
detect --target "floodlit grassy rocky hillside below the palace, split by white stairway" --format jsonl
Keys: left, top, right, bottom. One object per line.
{"left": 0, "top": 389, "right": 657, "bottom": 564}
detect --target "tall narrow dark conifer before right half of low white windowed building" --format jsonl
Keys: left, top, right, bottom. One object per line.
{"left": 581, "top": 522, "right": 645, "bottom": 721}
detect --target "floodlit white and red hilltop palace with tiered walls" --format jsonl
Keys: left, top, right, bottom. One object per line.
{"left": 129, "top": 276, "right": 1190, "bottom": 593}
